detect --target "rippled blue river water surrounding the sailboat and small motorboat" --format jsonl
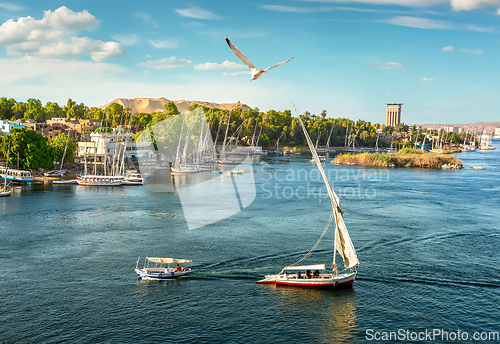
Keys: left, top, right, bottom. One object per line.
{"left": 0, "top": 141, "right": 500, "bottom": 343}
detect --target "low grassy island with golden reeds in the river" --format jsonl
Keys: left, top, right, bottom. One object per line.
{"left": 332, "top": 148, "right": 463, "bottom": 169}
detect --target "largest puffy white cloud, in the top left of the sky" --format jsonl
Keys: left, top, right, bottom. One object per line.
{"left": 0, "top": 6, "right": 125, "bottom": 61}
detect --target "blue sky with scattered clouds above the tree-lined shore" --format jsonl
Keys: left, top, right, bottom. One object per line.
{"left": 0, "top": 0, "right": 500, "bottom": 124}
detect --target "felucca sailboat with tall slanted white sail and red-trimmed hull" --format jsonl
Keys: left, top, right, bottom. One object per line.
{"left": 256, "top": 111, "right": 359, "bottom": 288}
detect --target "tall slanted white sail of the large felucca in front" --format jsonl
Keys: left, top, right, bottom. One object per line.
{"left": 298, "top": 116, "right": 359, "bottom": 269}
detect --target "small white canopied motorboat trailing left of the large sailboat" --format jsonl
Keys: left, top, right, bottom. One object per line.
{"left": 135, "top": 256, "right": 192, "bottom": 280}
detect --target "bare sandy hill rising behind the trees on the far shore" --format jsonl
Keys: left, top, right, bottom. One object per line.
{"left": 100, "top": 98, "right": 250, "bottom": 113}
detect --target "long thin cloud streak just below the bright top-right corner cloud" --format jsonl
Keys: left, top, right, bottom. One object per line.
{"left": 379, "top": 16, "right": 493, "bottom": 32}
